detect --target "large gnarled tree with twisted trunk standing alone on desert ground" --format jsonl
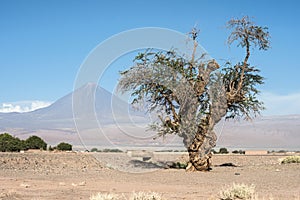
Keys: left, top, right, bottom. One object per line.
{"left": 118, "top": 17, "right": 269, "bottom": 171}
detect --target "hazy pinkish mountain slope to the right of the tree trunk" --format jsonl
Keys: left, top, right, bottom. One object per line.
{"left": 216, "top": 115, "right": 300, "bottom": 150}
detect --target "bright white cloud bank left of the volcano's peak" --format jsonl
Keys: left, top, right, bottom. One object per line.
{"left": 0, "top": 101, "right": 51, "bottom": 113}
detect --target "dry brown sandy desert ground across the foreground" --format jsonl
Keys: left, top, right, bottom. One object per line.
{"left": 0, "top": 152, "right": 300, "bottom": 200}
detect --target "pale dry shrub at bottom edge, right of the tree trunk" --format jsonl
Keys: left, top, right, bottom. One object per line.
{"left": 220, "top": 183, "right": 256, "bottom": 200}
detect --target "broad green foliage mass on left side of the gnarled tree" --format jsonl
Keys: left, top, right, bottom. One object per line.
{"left": 119, "top": 50, "right": 188, "bottom": 118}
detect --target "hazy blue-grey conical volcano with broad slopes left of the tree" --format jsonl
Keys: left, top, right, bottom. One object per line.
{"left": 0, "top": 83, "right": 161, "bottom": 146}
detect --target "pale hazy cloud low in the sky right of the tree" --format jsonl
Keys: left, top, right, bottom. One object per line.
{"left": 260, "top": 92, "right": 300, "bottom": 115}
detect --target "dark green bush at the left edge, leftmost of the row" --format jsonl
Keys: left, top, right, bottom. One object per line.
{"left": 0, "top": 133, "right": 24, "bottom": 152}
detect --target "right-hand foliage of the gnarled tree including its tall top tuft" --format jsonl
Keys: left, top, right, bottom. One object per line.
{"left": 223, "top": 16, "right": 270, "bottom": 119}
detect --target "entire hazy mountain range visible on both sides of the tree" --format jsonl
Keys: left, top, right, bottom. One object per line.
{"left": 0, "top": 83, "right": 300, "bottom": 150}
